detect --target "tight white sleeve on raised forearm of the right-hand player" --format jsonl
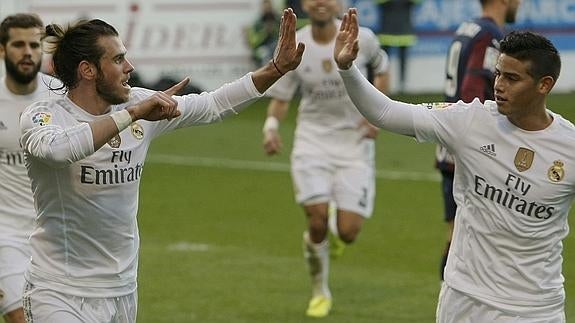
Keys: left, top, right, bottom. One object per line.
{"left": 339, "top": 65, "right": 418, "bottom": 136}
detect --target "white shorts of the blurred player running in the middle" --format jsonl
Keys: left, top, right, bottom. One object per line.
{"left": 291, "top": 155, "right": 375, "bottom": 218}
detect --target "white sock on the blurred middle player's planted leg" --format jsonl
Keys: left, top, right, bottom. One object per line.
{"left": 303, "top": 231, "right": 331, "bottom": 298}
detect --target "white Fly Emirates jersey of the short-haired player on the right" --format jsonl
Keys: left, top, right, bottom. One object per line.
{"left": 340, "top": 68, "right": 575, "bottom": 317}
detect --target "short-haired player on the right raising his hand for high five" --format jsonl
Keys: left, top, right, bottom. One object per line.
{"left": 334, "top": 9, "right": 575, "bottom": 323}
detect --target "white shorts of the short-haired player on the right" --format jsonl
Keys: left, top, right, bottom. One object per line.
{"left": 436, "top": 283, "right": 566, "bottom": 323}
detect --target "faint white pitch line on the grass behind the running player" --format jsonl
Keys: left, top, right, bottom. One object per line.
{"left": 147, "top": 154, "right": 441, "bottom": 182}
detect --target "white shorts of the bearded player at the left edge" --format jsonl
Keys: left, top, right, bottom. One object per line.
{"left": 0, "top": 244, "right": 30, "bottom": 315}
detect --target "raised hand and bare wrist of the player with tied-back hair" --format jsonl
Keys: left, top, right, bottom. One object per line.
{"left": 252, "top": 8, "right": 305, "bottom": 93}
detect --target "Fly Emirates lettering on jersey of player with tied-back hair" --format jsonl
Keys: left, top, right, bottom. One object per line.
{"left": 80, "top": 150, "right": 144, "bottom": 185}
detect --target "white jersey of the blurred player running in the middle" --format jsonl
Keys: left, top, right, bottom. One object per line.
{"left": 266, "top": 21, "right": 389, "bottom": 161}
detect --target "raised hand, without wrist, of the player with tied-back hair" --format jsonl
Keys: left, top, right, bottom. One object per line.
{"left": 273, "top": 8, "right": 305, "bottom": 74}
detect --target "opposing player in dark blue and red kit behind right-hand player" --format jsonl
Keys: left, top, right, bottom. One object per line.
{"left": 435, "top": 0, "right": 521, "bottom": 280}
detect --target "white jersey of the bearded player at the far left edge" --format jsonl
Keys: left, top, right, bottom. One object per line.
{"left": 0, "top": 73, "right": 59, "bottom": 246}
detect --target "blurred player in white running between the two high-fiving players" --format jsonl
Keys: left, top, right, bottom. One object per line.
{"left": 263, "top": 0, "right": 388, "bottom": 317}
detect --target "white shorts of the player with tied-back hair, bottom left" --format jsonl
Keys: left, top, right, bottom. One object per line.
{"left": 24, "top": 282, "right": 138, "bottom": 323}
